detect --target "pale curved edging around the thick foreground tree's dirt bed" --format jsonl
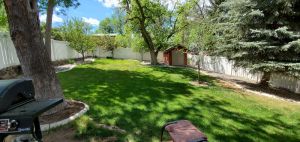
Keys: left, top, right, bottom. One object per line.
{"left": 41, "top": 101, "right": 89, "bottom": 131}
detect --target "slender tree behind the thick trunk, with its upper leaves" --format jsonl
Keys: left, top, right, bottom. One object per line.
{"left": 39, "top": 0, "right": 79, "bottom": 57}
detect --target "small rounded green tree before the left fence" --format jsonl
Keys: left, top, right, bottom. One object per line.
{"left": 62, "top": 18, "right": 96, "bottom": 61}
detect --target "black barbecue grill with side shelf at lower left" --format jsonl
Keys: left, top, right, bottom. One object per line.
{"left": 0, "top": 80, "right": 63, "bottom": 142}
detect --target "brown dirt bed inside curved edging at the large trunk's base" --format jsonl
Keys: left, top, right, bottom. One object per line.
{"left": 40, "top": 101, "right": 85, "bottom": 125}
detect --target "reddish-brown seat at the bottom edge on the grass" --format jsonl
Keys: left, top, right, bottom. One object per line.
{"left": 160, "top": 120, "right": 208, "bottom": 142}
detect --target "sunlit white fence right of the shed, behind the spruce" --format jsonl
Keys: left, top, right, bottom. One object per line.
{"left": 188, "top": 54, "right": 300, "bottom": 93}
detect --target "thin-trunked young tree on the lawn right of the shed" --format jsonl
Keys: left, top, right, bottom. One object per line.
{"left": 175, "top": 0, "right": 218, "bottom": 84}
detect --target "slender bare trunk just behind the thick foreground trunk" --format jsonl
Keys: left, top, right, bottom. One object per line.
{"left": 45, "top": 0, "right": 55, "bottom": 57}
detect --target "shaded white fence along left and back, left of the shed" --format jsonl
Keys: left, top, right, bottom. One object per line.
{"left": 0, "top": 33, "right": 163, "bottom": 69}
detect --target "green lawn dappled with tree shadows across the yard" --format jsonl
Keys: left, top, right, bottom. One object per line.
{"left": 59, "top": 59, "right": 300, "bottom": 142}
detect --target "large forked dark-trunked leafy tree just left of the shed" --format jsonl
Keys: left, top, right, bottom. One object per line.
{"left": 122, "top": 0, "right": 191, "bottom": 65}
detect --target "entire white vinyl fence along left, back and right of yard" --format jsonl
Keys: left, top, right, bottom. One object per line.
{"left": 0, "top": 33, "right": 300, "bottom": 93}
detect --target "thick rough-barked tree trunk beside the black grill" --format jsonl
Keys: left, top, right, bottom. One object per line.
{"left": 4, "top": 0, "right": 64, "bottom": 113}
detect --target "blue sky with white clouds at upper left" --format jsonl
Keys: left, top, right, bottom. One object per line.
{"left": 40, "top": 0, "right": 118, "bottom": 28}
